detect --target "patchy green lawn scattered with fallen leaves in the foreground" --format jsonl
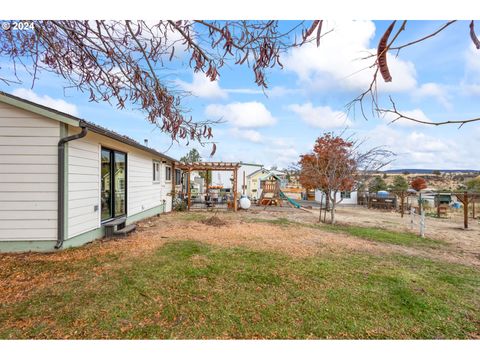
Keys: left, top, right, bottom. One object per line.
{"left": 0, "top": 241, "right": 480, "bottom": 339}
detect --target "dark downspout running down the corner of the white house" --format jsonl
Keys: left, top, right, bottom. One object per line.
{"left": 55, "top": 123, "right": 87, "bottom": 249}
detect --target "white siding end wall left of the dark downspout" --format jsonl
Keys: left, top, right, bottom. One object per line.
{"left": 0, "top": 103, "right": 60, "bottom": 242}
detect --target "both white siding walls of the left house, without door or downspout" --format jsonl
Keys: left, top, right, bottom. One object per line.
{"left": 0, "top": 102, "right": 174, "bottom": 252}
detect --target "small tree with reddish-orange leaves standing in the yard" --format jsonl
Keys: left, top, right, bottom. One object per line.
{"left": 300, "top": 133, "right": 393, "bottom": 224}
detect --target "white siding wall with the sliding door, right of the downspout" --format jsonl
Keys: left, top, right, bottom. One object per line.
{"left": 67, "top": 128, "right": 172, "bottom": 238}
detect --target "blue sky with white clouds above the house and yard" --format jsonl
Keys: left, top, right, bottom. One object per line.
{"left": 0, "top": 20, "right": 480, "bottom": 169}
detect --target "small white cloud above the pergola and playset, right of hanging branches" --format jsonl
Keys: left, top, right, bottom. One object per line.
{"left": 205, "top": 101, "right": 277, "bottom": 128}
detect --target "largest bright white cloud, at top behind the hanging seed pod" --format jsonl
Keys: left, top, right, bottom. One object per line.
{"left": 284, "top": 21, "right": 417, "bottom": 92}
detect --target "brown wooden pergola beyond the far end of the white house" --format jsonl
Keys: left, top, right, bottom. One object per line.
{"left": 174, "top": 162, "right": 241, "bottom": 211}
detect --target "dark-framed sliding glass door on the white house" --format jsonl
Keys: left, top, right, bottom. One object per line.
{"left": 101, "top": 148, "right": 127, "bottom": 221}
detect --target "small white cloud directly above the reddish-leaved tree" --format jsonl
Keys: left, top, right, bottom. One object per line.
{"left": 288, "top": 103, "right": 352, "bottom": 129}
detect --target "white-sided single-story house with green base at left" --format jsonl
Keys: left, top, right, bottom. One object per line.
{"left": 0, "top": 92, "right": 181, "bottom": 251}
